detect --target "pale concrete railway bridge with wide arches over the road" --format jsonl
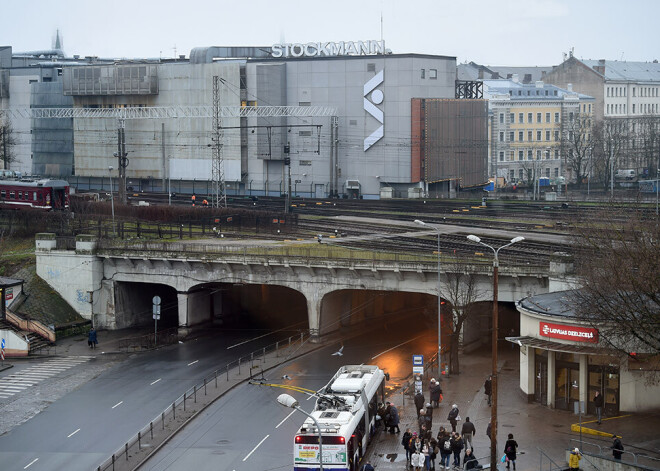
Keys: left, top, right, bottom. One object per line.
{"left": 36, "top": 234, "right": 572, "bottom": 335}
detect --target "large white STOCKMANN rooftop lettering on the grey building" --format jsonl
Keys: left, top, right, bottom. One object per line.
{"left": 271, "top": 41, "right": 385, "bottom": 57}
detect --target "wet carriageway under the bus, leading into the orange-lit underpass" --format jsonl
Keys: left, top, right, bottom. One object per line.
{"left": 139, "top": 319, "right": 437, "bottom": 471}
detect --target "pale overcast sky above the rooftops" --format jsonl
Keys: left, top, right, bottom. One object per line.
{"left": 0, "top": 0, "right": 660, "bottom": 66}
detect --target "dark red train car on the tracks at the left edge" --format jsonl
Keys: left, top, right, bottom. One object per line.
{"left": 0, "top": 178, "right": 69, "bottom": 211}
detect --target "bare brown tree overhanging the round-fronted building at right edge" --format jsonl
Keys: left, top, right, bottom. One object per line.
{"left": 572, "top": 208, "right": 660, "bottom": 366}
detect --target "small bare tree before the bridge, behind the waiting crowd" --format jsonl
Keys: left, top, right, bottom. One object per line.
{"left": 440, "top": 257, "right": 481, "bottom": 374}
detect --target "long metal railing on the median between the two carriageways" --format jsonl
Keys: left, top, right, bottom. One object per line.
{"left": 96, "top": 331, "right": 309, "bottom": 471}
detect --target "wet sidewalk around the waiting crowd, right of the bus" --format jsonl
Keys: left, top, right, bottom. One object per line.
{"left": 367, "top": 348, "right": 660, "bottom": 471}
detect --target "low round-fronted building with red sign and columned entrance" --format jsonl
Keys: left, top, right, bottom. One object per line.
{"left": 507, "top": 291, "right": 660, "bottom": 416}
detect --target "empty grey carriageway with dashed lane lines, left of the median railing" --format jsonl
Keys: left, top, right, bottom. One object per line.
{"left": 0, "top": 331, "right": 300, "bottom": 471}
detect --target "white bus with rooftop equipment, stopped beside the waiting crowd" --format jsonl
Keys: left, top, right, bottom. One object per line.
{"left": 293, "top": 365, "right": 389, "bottom": 471}
